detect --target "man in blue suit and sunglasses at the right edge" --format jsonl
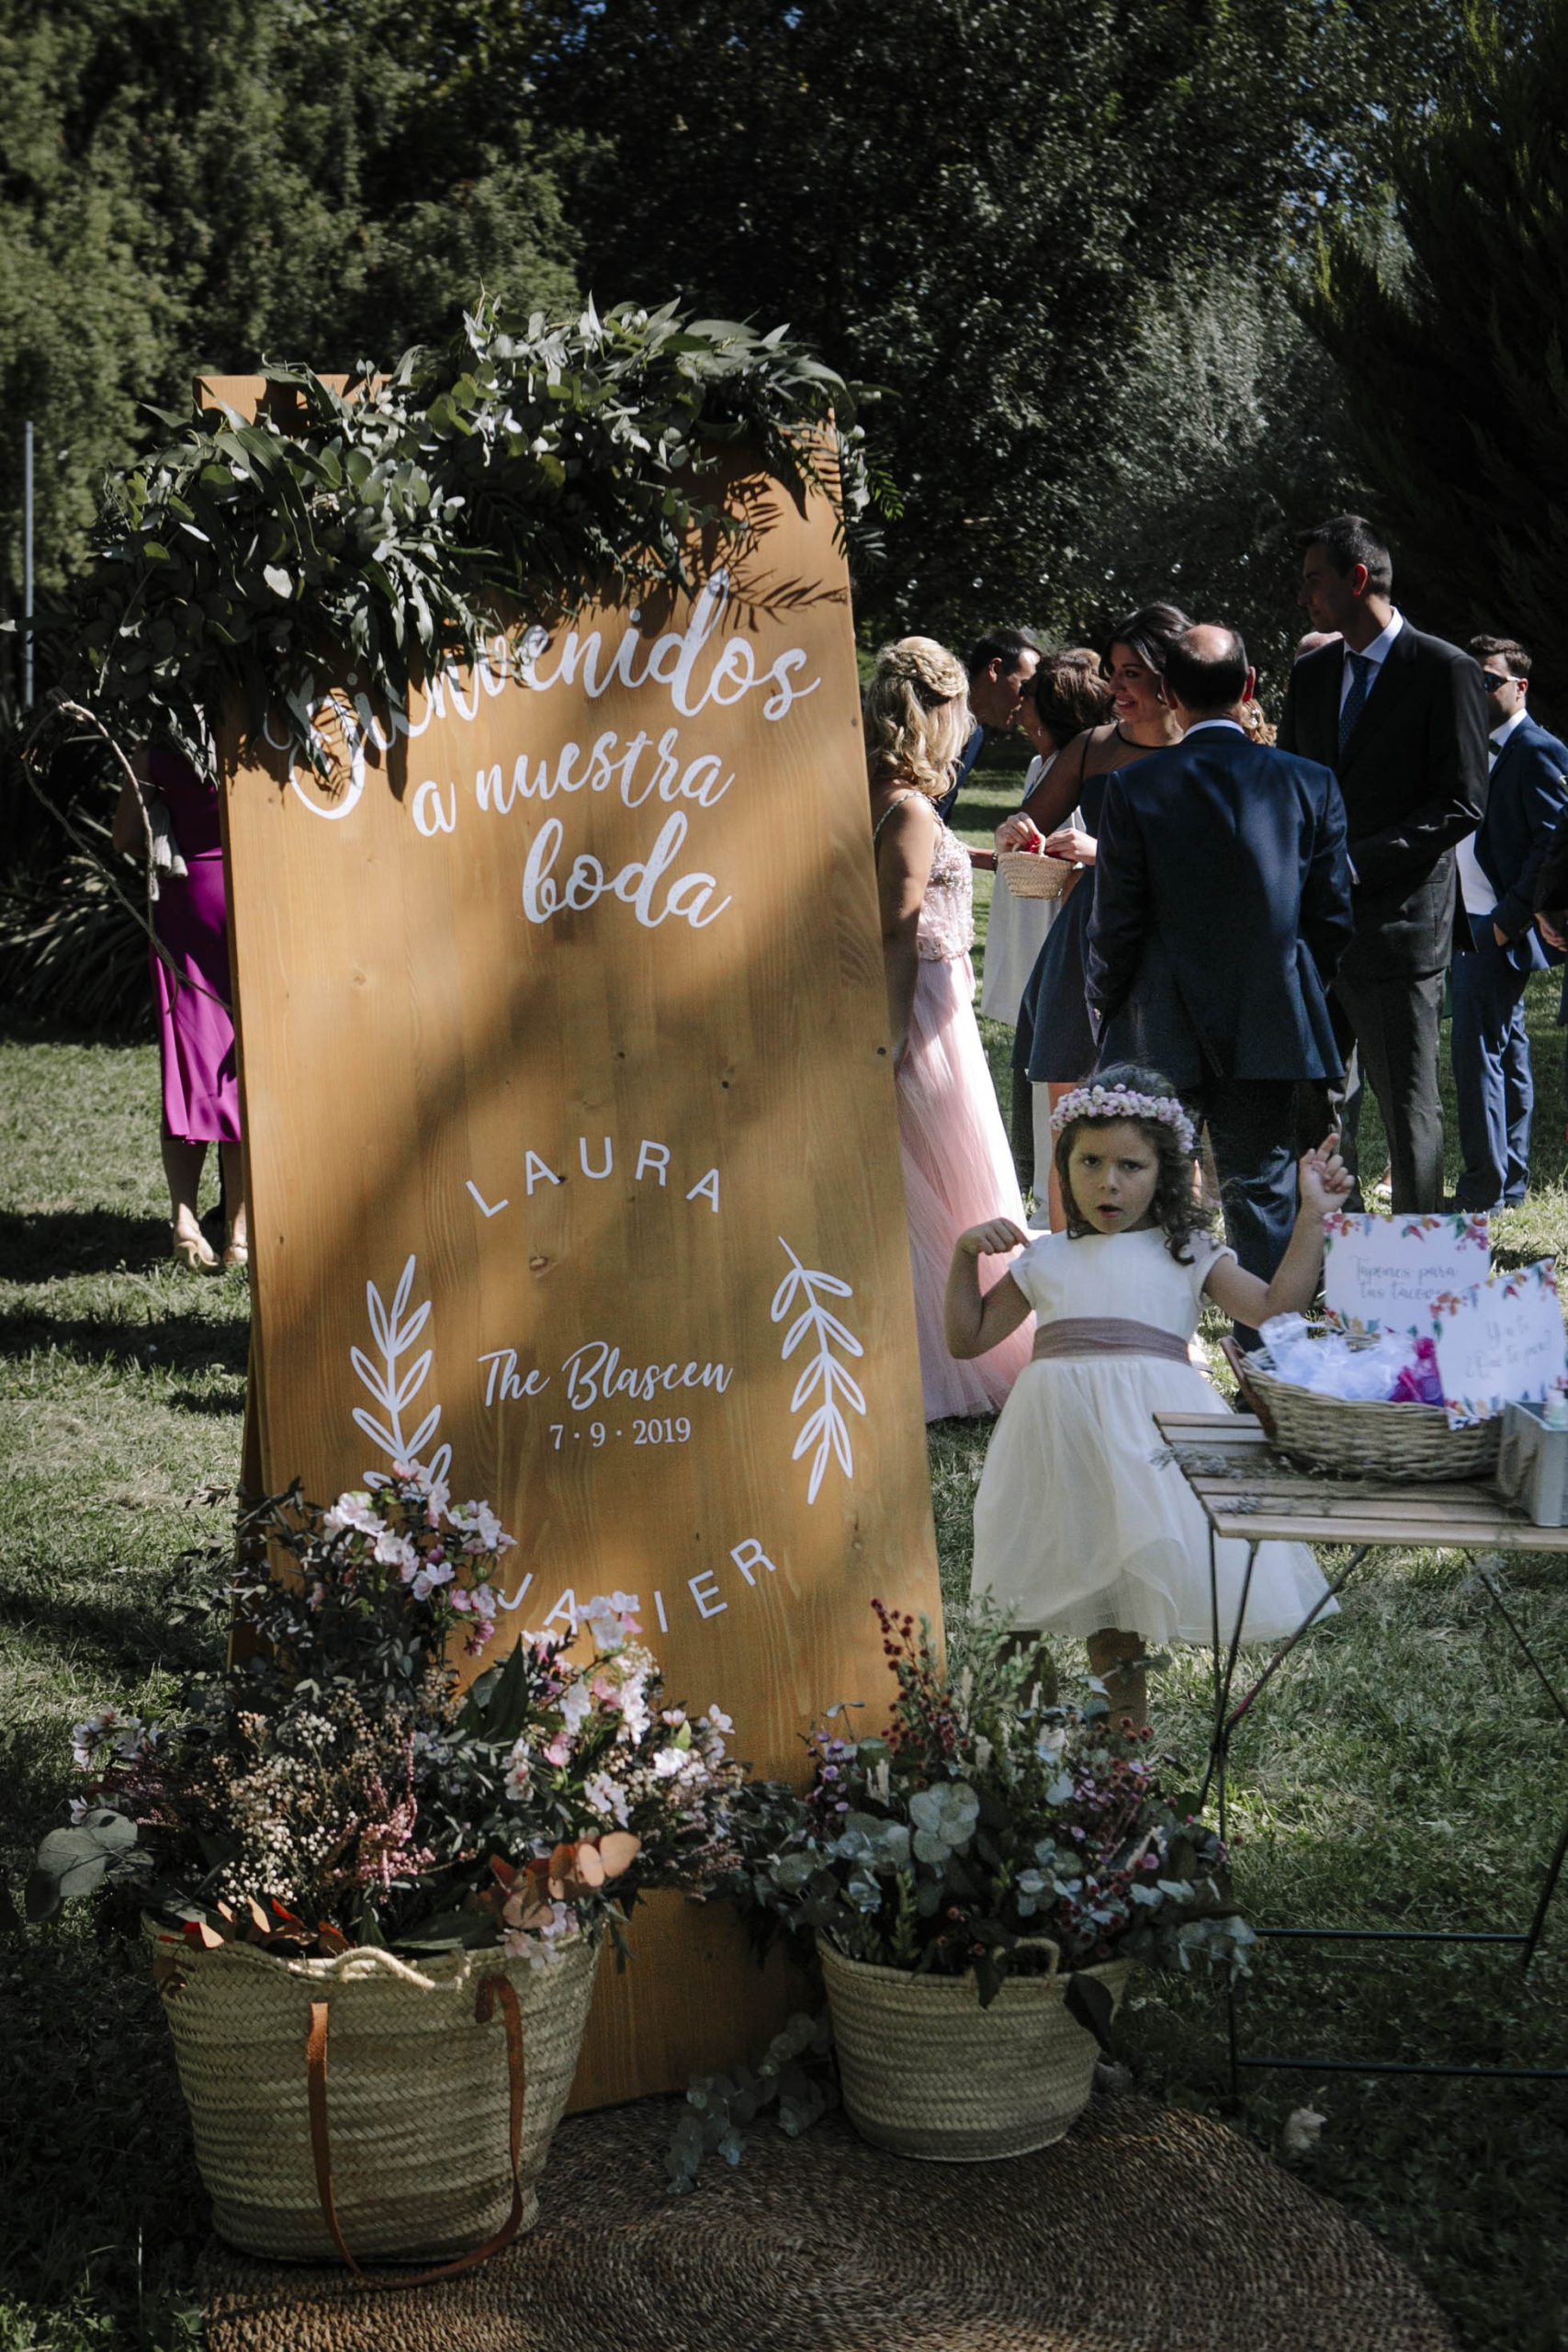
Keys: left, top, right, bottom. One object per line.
{"left": 1450, "top": 638, "right": 1568, "bottom": 1209}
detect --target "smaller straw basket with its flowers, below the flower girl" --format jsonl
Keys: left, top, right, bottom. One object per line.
{"left": 731, "top": 1601, "right": 1253, "bottom": 2162}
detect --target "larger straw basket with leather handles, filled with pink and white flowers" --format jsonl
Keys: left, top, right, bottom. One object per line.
{"left": 28, "top": 1465, "right": 740, "bottom": 2284}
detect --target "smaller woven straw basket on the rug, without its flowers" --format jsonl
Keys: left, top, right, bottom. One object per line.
{"left": 818, "top": 1938, "right": 1134, "bottom": 2164}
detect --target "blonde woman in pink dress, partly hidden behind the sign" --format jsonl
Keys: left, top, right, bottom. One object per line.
{"left": 865, "top": 638, "right": 1030, "bottom": 1420}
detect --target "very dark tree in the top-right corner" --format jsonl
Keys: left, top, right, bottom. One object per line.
{"left": 1307, "top": 0, "right": 1568, "bottom": 719}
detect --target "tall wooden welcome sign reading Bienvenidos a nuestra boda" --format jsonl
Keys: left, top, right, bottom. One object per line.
{"left": 210, "top": 386, "right": 938, "bottom": 2105}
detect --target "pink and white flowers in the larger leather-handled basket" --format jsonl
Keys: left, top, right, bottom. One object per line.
{"left": 26, "top": 1463, "right": 743, "bottom": 1962}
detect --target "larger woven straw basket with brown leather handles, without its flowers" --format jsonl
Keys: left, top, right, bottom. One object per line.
{"left": 143, "top": 1919, "right": 600, "bottom": 2267}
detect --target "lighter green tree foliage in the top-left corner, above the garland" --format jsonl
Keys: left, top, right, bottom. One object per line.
{"left": 0, "top": 0, "right": 576, "bottom": 609}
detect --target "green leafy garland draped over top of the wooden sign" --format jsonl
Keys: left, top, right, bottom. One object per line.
{"left": 50, "top": 301, "right": 872, "bottom": 760}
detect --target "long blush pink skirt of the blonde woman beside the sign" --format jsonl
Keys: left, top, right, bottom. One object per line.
{"left": 898, "top": 955, "right": 1034, "bottom": 1420}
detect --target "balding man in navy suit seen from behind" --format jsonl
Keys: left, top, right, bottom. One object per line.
{"left": 1089, "top": 626, "right": 1352, "bottom": 1326}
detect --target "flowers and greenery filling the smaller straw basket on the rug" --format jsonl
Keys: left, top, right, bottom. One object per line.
{"left": 731, "top": 1601, "right": 1253, "bottom": 2002}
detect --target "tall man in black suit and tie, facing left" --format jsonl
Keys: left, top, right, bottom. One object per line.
{"left": 1279, "top": 515, "right": 1485, "bottom": 1214}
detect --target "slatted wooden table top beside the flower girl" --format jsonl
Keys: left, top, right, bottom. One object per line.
{"left": 1155, "top": 1414, "right": 1568, "bottom": 1553}
